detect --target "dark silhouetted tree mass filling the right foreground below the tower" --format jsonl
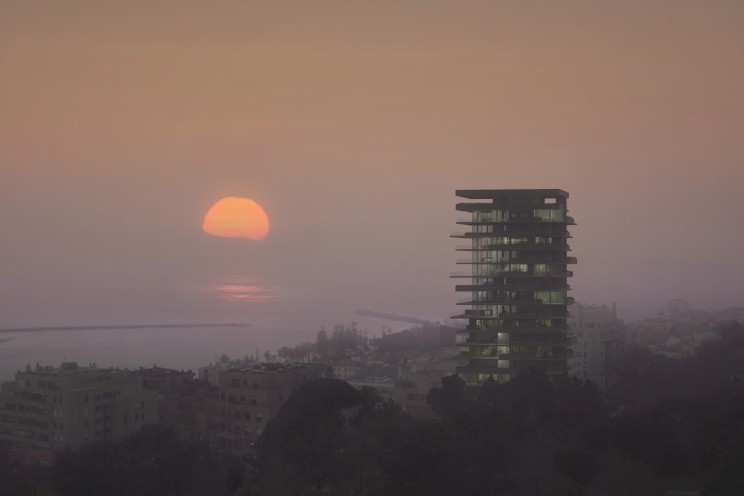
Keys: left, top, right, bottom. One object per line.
{"left": 243, "top": 334, "right": 744, "bottom": 496}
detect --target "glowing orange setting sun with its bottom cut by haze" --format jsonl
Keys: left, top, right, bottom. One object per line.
{"left": 202, "top": 196, "right": 269, "bottom": 241}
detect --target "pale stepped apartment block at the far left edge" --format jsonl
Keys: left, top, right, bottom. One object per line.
{"left": 0, "top": 362, "right": 157, "bottom": 449}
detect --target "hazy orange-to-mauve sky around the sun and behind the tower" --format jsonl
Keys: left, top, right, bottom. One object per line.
{"left": 0, "top": 0, "right": 744, "bottom": 332}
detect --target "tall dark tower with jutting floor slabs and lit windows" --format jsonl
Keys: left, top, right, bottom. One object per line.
{"left": 453, "top": 189, "right": 576, "bottom": 385}
